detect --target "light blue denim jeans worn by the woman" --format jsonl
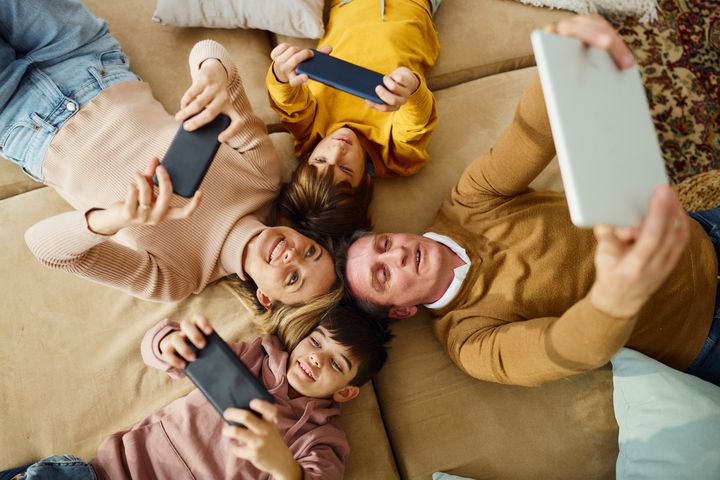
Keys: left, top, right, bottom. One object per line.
{"left": 0, "top": 0, "right": 139, "bottom": 181}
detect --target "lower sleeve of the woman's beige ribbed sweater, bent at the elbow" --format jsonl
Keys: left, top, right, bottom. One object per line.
{"left": 25, "top": 211, "right": 197, "bottom": 301}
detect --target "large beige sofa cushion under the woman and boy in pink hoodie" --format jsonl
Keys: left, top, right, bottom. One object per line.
{"left": 0, "top": 187, "right": 397, "bottom": 479}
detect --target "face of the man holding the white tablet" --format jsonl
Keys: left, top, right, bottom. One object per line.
{"left": 346, "top": 233, "right": 454, "bottom": 317}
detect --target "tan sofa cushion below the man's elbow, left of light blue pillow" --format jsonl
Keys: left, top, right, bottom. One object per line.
{"left": 375, "top": 310, "right": 618, "bottom": 480}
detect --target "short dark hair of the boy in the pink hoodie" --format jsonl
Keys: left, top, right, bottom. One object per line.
{"left": 319, "top": 304, "right": 392, "bottom": 387}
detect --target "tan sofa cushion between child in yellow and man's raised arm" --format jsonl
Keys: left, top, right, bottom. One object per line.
{"left": 370, "top": 67, "right": 562, "bottom": 233}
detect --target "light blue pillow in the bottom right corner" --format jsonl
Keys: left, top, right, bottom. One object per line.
{"left": 612, "top": 348, "right": 720, "bottom": 480}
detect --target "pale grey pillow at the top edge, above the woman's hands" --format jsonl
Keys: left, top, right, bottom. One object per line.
{"left": 153, "top": 0, "right": 325, "bottom": 38}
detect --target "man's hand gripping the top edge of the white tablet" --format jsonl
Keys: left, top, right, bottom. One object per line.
{"left": 545, "top": 15, "right": 635, "bottom": 69}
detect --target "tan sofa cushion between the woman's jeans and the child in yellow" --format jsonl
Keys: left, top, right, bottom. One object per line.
{"left": 84, "top": 0, "right": 277, "bottom": 123}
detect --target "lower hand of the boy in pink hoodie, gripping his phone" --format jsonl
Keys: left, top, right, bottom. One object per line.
{"left": 223, "top": 400, "right": 302, "bottom": 480}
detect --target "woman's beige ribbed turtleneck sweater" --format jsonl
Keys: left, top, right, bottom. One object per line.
{"left": 25, "top": 40, "right": 280, "bottom": 301}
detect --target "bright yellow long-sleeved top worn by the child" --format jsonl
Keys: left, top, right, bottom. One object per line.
{"left": 266, "top": 0, "right": 440, "bottom": 175}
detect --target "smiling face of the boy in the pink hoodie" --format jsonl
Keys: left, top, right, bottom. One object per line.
{"left": 287, "top": 327, "right": 359, "bottom": 402}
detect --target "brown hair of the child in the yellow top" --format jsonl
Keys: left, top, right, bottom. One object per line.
{"left": 277, "top": 155, "right": 372, "bottom": 238}
